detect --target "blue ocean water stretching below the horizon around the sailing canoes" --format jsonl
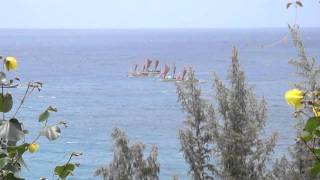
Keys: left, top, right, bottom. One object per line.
{"left": 0, "top": 29, "right": 320, "bottom": 179}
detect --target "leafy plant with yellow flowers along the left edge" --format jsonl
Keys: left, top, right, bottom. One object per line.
{"left": 0, "top": 56, "right": 79, "bottom": 180}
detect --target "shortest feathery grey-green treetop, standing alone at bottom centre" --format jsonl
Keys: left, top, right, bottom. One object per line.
{"left": 95, "top": 128, "right": 160, "bottom": 180}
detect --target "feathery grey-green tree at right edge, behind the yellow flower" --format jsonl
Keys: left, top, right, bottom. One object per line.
{"left": 273, "top": 25, "right": 320, "bottom": 180}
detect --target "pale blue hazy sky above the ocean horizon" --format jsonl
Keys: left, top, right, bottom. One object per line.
{"left": 0, "top": 0, "right": 320, "bottom": 29}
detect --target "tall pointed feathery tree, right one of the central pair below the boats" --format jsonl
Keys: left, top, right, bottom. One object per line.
{"left": 214, "top": 48, "right": 276, "bottom": 179}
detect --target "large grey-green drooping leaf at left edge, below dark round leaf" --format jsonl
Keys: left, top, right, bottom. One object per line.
{"left": 0, "top": 119, "right": 24, "bottom": 146}
